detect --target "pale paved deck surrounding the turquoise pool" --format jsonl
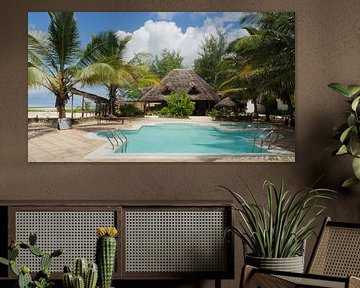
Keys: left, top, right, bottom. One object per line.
{"left": 28, "top": 117, "right": 295, "bottom": 162}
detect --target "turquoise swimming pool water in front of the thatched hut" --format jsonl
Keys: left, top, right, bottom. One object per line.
{"left": 98, "top": 123, "right": 268, "bottom": 154}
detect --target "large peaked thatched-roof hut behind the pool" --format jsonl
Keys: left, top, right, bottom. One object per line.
{"left": 141, "top": 69, "right": 220, "bottom": 115}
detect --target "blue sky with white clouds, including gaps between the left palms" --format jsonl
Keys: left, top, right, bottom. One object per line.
{"left": 28, "top": 12, "right": 248, "bottom": 107}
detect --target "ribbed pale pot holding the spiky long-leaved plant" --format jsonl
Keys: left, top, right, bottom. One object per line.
{"left": 245, "top": 255, "right": 304, "bottom": 273}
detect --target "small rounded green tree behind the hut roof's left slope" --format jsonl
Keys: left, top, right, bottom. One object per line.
{"left": 150, "top": 49, "right": 183, "bottom": 78}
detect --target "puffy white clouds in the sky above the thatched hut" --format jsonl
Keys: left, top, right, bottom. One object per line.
{"left": 118, "top": 12, "right": 250, "bottom": 67}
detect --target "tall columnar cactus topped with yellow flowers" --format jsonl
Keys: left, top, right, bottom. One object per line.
{"left": 96, "top": 227, "right": 118, "bottom": 288}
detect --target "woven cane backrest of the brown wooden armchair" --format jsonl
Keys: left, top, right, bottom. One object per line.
{"left": 307, "top": 218, "right": 360, "bottom": 277}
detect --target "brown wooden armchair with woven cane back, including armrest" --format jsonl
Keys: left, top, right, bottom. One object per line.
{"left": 240, "top": 218, "right": 360, "bottom": 288}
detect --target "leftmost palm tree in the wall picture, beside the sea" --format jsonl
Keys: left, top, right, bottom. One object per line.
{"left": 28, "top": 12, "right": 80, "bottom": 118}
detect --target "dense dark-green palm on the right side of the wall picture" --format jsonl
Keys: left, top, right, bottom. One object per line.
{"left": 222, "top": 12, "right": 295, "bottom": 119}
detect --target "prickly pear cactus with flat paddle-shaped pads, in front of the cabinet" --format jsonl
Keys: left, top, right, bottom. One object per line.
{"left": 0, "top": 233, "right": 64, "bottom": 288}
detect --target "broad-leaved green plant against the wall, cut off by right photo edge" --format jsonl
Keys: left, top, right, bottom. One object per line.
{"left": 329, "top": 83, "right": 360, "bottom": 187}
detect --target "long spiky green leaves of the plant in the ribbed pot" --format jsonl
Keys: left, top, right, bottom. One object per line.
{"left": 220, "top": 180, "right": 333, "bottom": 258}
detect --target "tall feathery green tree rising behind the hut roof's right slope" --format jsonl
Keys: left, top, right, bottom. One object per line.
{"left": 194, "top": 31, "right": 227, "bottom": 87}
